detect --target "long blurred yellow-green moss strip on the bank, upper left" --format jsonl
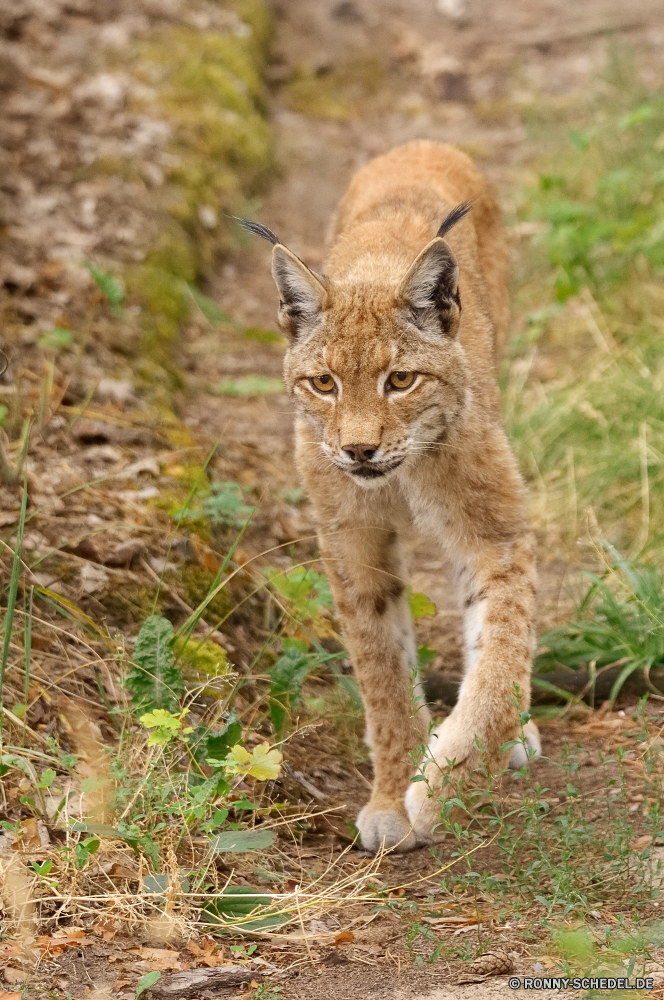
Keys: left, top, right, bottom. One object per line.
{"left": 109, "top": 0, "right": 274, "bottom": 398}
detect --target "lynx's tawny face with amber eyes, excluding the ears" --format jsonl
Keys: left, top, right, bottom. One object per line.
{"left": 286, "top": 292, "right": 468, "bottom": 486}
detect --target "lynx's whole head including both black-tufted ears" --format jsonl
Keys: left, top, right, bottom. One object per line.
{"left": 239, "top": 205, "right": 471, "bottom": 486}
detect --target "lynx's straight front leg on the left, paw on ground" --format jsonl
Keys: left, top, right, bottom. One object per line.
{"left": 321, "top": 526, "right": 429, "bottom": 851}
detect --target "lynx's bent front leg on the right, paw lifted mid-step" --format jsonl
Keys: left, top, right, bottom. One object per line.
{"left": 406, "top": 535, "right": 539, "bottom": 839}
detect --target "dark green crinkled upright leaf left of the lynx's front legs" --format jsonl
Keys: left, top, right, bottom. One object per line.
{"left": 125, "top": 615, "right": 184, "bottom": 716}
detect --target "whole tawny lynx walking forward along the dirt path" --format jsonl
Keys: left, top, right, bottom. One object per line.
{"left": 245, "top": 142, "right": 539, "bottom": 851}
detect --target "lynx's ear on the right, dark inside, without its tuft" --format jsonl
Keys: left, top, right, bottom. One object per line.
{"left": 397, "top": 236, "right": 461, "bottom": 337}
